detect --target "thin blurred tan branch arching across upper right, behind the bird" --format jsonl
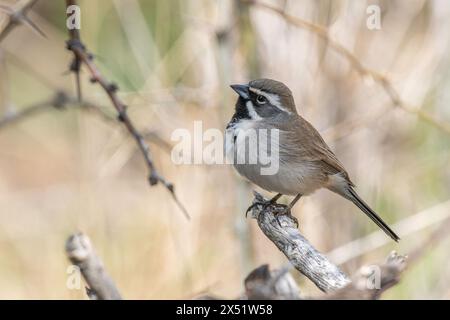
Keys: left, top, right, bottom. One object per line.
{"left": 244, "top": 0, "right": 450, "bottom": 134}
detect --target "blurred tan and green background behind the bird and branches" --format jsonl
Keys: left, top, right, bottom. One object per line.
{"left": 0, "top": 0, "right": 450, "bottom": 299}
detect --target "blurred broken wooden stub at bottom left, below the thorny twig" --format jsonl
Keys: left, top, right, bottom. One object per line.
{"left": 66, "top": 233, "right": 122, "bottom": 300}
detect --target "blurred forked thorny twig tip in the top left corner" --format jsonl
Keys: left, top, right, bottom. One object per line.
{"left": 0, "top": 0, "right": 46, "bottom": 42}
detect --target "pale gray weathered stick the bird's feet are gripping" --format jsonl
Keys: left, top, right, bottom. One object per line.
{"left": 252, "top": 192, "right": 350, "bottom": 292}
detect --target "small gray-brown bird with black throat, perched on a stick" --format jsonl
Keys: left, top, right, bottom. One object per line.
{"left": 225, "top": 79, "right": 400, "bottom": 242}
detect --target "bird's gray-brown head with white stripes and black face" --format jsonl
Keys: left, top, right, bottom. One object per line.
{"left": 231, "top": 79, "right": 297, "bottom": 120}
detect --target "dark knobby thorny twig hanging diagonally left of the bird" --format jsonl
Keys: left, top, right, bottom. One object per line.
{"left": 66, "top": 0, "right": 190, "bottom": 219}
